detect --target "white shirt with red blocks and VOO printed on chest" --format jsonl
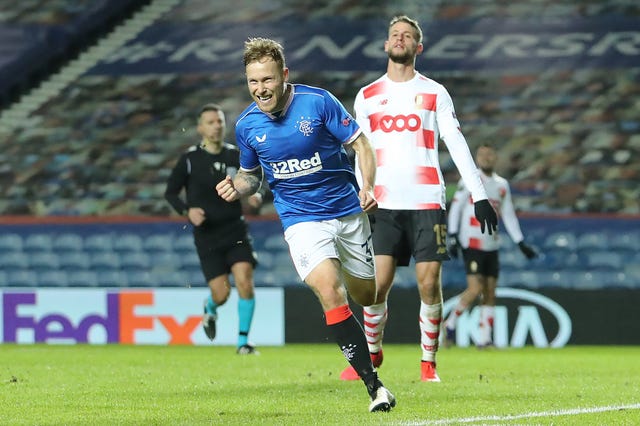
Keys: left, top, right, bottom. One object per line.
{"left": 354, "top": 72, "right": 487, "bottom": 210}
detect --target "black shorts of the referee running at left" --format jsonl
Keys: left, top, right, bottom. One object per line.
{"left": 194, "top": 221, "right": 258, "bottom": 282}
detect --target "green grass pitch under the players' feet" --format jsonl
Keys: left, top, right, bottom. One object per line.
{"left": 0, "top": 344, "right": 640, "bottom": 425}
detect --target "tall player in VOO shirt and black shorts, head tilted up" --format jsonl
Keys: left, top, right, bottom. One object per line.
{"left": 340, "top": 16, "right": 498, "bottom": 382}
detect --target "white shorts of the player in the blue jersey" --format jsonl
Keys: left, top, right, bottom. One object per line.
{"left": 284, "top": 213, "right": 375, "bottom": 281}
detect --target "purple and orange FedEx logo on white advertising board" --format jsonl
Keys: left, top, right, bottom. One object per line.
{"left": 2, "top": 290, "right": 201, "bottom": 344}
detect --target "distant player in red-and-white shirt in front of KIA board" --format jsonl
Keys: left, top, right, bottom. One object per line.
{"left": 445, "top": 144, "right": 537, "bottom": 348}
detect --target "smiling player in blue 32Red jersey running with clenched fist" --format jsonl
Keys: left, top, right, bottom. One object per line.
{"left": 216, "top": 38, "right": 396, "bottom": 412}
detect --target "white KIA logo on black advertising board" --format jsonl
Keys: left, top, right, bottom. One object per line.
{"left": 442, "top": 288, "right": 572, "bottom": 348}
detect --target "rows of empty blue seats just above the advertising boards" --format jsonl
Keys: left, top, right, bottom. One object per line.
{"left": 0, "top": 216, "right": 640, "bottom": 290}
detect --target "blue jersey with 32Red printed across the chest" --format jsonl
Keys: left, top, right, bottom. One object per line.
{"left": 236, "top": 84, "right": 362, "bottom": 229}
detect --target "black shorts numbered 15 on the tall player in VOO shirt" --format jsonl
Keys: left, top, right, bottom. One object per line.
{"left": 371, "top": 209, "right": 449, "bottom": 266}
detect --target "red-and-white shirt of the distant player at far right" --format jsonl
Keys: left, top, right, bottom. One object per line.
{"left": 447, "top": 173, "right": 524, "bottom": 251}
